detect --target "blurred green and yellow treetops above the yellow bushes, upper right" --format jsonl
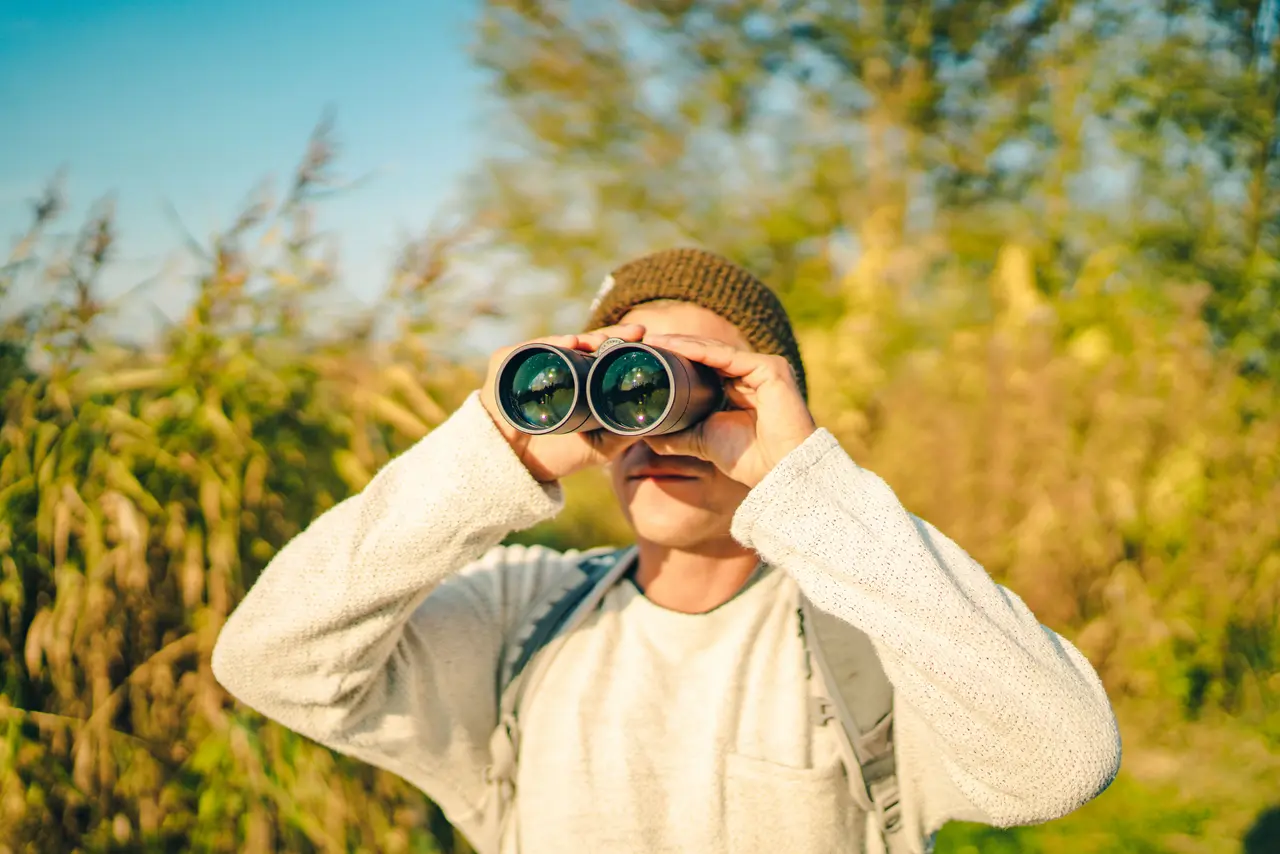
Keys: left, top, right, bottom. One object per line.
{"left": 475, "top": 0, "right": 1280, "bottom": 375}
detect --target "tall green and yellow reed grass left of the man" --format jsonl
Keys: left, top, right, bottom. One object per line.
{"left": 0, "top": 133, "right": 481, "bottom": 851}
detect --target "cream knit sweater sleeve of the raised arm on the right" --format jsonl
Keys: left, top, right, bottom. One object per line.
{"left": 732, "top": 430, "right": 1120, "bottom": 831}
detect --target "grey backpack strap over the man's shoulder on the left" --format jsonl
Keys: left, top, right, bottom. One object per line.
{"left": 484, "top": 547, "right": 635, "bottom": 851}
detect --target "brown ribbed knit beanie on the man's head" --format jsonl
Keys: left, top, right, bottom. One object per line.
{"left": 586, "top": 248, "right": 808, "bottom": 399}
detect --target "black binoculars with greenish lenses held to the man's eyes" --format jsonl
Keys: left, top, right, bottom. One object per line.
{"left": 494, "top": 338, "right": 726, "bottom": 435}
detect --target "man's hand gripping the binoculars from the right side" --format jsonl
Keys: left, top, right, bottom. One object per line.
{"left": 644, "top": 335, "right": 818, "bottom": 487}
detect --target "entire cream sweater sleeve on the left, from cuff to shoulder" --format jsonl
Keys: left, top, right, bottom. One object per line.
{"left": 212, "top": 394, "right": 572, "bottom": 827}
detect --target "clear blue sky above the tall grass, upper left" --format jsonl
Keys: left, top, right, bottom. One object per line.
{"left": 0, "top": 0, "right": 485, "bottom": 330}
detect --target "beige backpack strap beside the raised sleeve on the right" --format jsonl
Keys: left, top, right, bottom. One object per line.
{"left": 800, "top": 595, "right": 911, "bottom": 854}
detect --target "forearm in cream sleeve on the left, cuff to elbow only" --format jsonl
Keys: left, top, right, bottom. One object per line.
{"left": 214, "top": 396, "right": 561, "bottom": 739}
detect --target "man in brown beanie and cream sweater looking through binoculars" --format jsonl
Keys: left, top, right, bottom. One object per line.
{"left": 214, "top": 250, "right": 1120, "bottom": 854}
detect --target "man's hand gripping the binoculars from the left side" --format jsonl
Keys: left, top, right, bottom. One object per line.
{"left": 480, "top": 324, "right": 645, "bottom": 483}
